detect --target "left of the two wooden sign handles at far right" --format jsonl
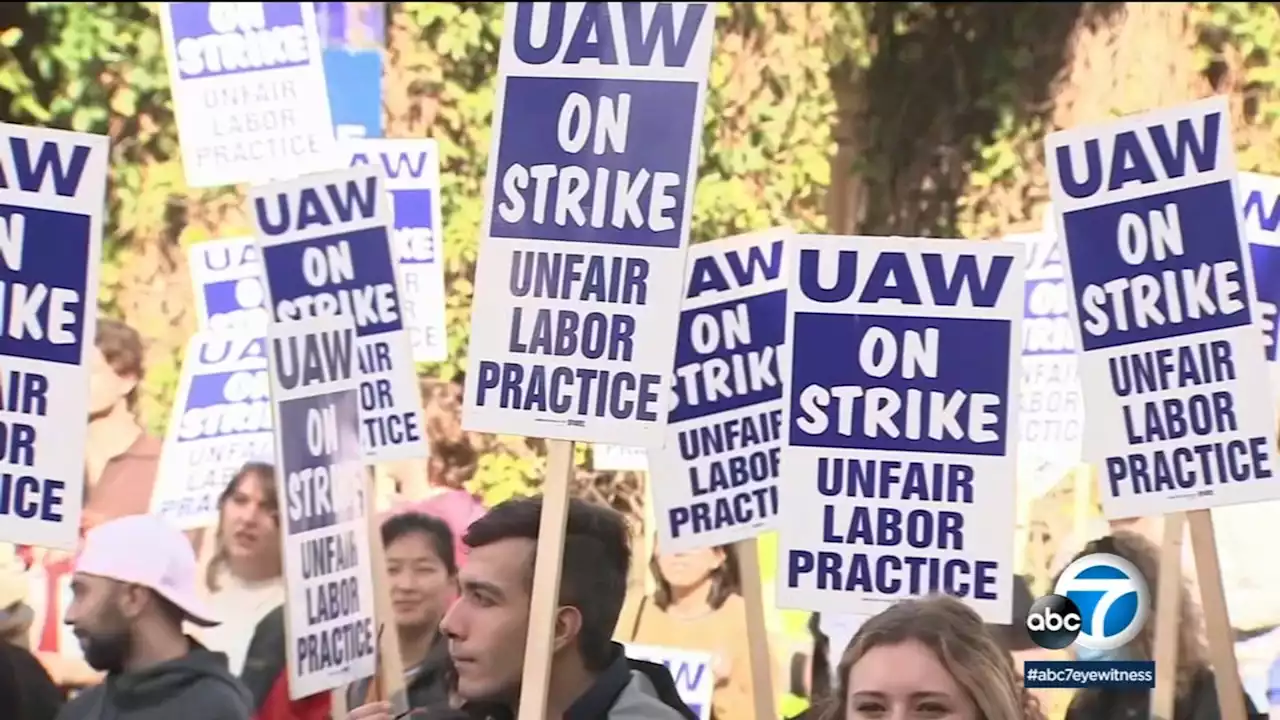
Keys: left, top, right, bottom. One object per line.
{"left": 1151, "top": 512, "right": 1187, "bottom": 720}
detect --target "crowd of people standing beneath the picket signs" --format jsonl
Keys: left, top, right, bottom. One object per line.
{"left": 0, "top": 319, "right": 1262, "bottom": 720}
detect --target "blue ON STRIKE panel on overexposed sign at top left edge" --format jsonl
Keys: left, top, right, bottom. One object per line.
{"left": 165, "top": 3, "right": 311, "bottom": 79}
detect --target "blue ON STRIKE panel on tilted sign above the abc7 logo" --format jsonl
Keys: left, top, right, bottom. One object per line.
{"left": 1062, "top": 181, "right": 1252, "bottom": 351}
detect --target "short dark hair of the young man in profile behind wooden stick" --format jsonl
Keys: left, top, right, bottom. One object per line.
{"left": 462, "top": 496, "right": 631, "bottom": 671}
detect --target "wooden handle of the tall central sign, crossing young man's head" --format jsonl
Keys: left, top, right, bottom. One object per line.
{"left": 517, "top": 439, "right": 573, "bottom": 720}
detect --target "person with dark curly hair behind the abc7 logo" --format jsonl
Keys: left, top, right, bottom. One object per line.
{"left": 1055, "top": 530, "right": 1258, "bottom": 720}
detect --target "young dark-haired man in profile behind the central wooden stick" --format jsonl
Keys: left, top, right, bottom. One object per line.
{"left": 348, "top": 497, "right": 696, "bottom": 720}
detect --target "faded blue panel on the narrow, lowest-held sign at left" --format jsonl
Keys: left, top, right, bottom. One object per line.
{"left": 276, "top": 391, "right": 360, "bottom": 536}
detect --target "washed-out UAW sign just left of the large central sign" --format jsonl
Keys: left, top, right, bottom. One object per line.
{"left": 340, "top": 138, "right": 449, "bottom": 363}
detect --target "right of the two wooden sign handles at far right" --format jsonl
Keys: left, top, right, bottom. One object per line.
{"left": 1187, "top": 510, "right": 1248, "bottom": 720}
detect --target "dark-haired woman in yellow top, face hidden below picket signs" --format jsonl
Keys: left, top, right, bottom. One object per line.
{"left": 617, "top": 546, "right": 755, "bottom": 720}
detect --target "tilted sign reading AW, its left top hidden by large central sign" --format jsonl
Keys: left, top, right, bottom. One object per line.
{"left": 649, "top": 228, "right": 792, "bottom": 552}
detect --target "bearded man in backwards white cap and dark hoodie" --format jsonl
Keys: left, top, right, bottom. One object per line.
{"left": 58, "top": 515, "right": 252, "bottom": 720}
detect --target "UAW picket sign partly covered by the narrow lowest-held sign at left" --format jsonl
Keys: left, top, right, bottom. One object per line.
{"left": 248, "top": 165, "right": 428, "bottom": 462}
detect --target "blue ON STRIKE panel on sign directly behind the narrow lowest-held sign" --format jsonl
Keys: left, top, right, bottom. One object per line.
{"left": 262, "top": 228, "right": 404, "bottom": 337}
